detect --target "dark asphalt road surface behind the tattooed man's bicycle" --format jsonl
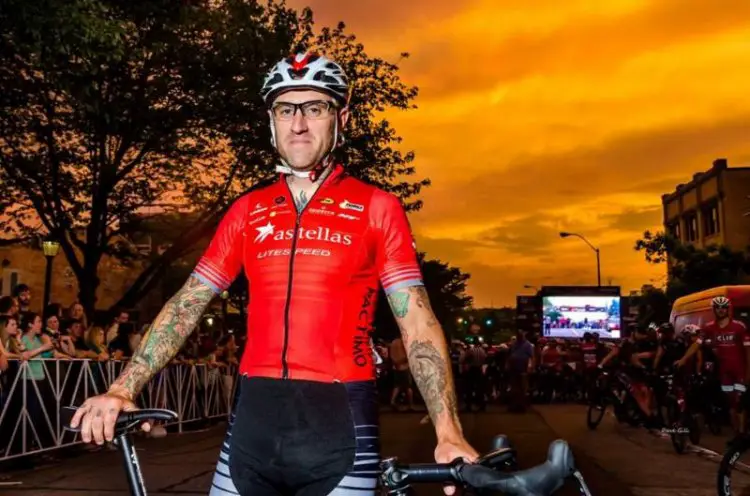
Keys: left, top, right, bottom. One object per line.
{"left": 0, "top": 405, "right": 750, "bottom": 496}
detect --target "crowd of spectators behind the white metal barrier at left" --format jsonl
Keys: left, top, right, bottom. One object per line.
{"left": 0, "top": 284, "right": 241, "bottom": 458}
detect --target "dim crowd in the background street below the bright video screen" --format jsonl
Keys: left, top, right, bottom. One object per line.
{"left": 376, "top": 331, "right": 613, "bottom": 418}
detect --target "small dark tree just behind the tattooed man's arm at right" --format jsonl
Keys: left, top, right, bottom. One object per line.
{"left": 374, "top": 253, "right": 472, "bottom": 339}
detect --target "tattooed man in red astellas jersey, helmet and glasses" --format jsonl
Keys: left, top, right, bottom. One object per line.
{"left": 67, "top": 54, "right": 477, "bottom": 496}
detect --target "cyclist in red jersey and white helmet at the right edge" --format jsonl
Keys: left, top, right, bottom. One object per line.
{"left": 677, "top": 296, "right": 750, "bottom": 433}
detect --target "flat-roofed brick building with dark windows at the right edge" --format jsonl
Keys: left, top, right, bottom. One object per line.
{"left": 662, "top": 159, "right": 750, "bottom": 251}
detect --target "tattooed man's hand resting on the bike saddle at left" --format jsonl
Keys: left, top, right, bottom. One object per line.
{"left": 70, "top": 392, "right": 151, "bottom": 445}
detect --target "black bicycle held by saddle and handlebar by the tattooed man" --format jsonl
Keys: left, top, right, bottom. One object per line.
{"left": 61, "top": 407, "right": 591, "bottom": 496}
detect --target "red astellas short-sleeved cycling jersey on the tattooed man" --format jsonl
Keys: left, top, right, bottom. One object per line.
{"left": 193, "top": 165, "right": 422, "bottom": 382}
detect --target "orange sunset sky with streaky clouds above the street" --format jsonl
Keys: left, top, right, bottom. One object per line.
{"left": 288, "top": 0, "right": 750, "bottom": 306}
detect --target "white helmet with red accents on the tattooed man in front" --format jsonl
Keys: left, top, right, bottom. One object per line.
{"left": 260, "top": 53, "right": 349, "bottom": 106}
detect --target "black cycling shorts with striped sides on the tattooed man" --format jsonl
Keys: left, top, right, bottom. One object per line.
{"left": 209, "top": 376, "right": 380, "bottom": 496}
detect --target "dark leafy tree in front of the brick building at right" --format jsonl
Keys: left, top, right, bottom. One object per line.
{"left": 635, "top": 231, "right": 750, "bottom": 302}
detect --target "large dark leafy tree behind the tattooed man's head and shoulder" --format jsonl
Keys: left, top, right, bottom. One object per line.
{"left": 0, "top": 0, "right": 428, "bottom": 312}
